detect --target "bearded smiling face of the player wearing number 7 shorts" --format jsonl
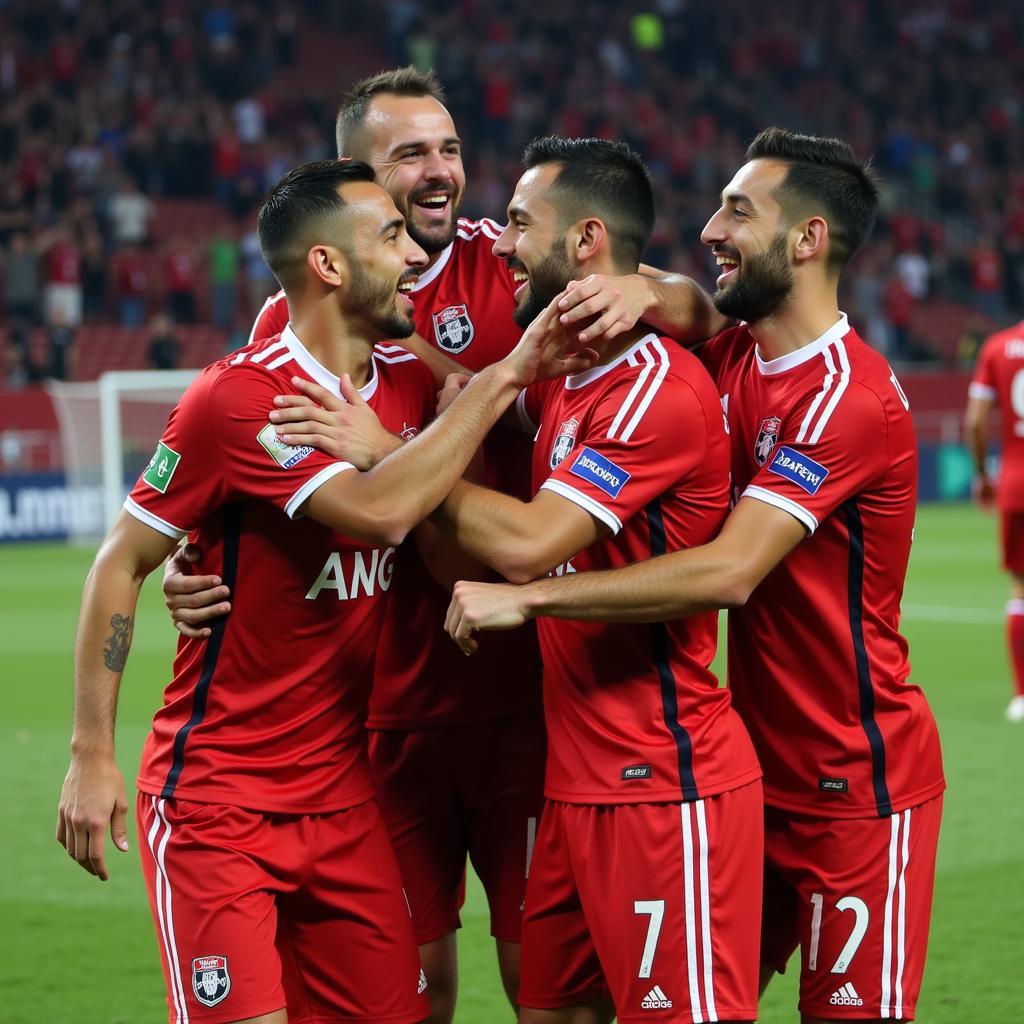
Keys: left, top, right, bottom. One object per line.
{"left": 494, "top": 164, "right": 573, "bottom": 328}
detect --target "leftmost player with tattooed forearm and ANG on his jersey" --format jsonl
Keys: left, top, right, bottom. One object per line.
{"left": 57, "top": 161, "right": 589, "bottom": 1024}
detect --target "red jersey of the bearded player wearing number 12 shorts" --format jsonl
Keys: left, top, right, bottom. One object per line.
{"left": 703, "top": 315, "right": 945, "bottom": 818}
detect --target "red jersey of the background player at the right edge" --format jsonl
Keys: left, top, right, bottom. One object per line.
{"left": 969, "top": 321, "right": 1024, "bottom": 512}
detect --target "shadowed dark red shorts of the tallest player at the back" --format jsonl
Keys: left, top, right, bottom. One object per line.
{"left": 370, "top": 711, "right": 546, "bottom": 944}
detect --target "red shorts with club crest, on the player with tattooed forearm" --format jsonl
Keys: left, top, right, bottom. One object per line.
{"left": 136, "top": 793, "right": 428, "bottom": 1024}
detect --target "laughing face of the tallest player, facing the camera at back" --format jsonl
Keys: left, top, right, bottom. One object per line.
{"left": 349, "top": 93, "right": 466, "bottom": 255}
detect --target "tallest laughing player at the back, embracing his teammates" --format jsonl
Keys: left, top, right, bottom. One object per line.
{"left": 165, "top": 68, "right": 716, "bottom": 1024}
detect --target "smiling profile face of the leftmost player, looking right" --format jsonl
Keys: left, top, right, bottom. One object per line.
{"left": 340, "top": 181, "right": 427, "bottom": 338}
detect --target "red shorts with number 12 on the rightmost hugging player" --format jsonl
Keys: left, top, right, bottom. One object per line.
{"left": 761, "top": 797, "right": 942, "bottom": 1020}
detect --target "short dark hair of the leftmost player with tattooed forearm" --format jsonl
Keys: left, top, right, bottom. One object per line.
{"left": 256, "top": 160, "right": 374, "bottom": 288}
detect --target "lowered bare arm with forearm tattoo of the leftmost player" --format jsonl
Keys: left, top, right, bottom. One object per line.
{"left": 56, "top": 512, "right": 175, "bottom": 882}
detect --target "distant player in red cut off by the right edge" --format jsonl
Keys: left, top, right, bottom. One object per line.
{"left": 964, "top": 321, "right": 1024, "bottom": 722}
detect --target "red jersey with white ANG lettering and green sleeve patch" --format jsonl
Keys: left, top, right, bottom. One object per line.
{"left": 125, "top": 329, "right": 435, "bottom": 814}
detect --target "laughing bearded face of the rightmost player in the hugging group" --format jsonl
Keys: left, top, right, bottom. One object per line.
{"left": 700, "top": 160, "right": 794, "bottom": 324}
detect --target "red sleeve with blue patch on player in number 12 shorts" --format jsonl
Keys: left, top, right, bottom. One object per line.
{"left": 742, "top": 383, "right": 890, "bottom": 534}
